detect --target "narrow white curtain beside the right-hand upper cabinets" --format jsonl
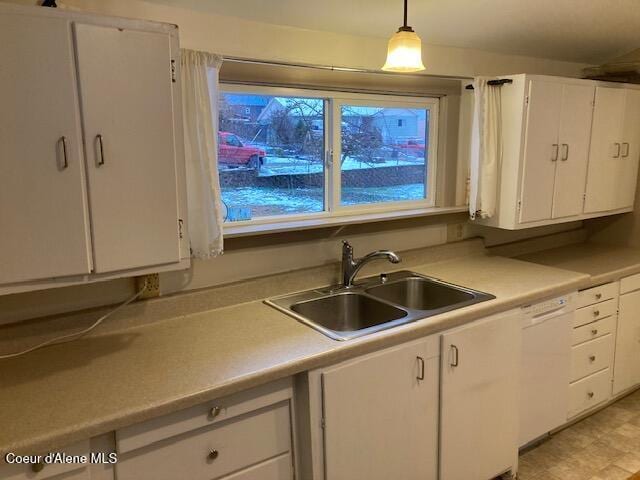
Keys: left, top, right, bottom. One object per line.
{"left": 469, "top": 78, "right": 502, "bottom": 218}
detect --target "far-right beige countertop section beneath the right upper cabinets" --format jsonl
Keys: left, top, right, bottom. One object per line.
{"left": 516, "top": 242, "right": 640, "bottom": 286}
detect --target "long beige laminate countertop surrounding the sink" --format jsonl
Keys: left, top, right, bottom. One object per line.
{"left": 0, "top": 253, "right": 600, "bottom": 456}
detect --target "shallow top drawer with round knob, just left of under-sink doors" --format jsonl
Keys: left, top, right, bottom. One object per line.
{"left": 116, "top": 378, "right": 293, "bottom": 453}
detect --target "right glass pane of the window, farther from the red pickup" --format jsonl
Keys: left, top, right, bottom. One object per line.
{"left": 340, "top": 105, "right": 429, "bottom": 205}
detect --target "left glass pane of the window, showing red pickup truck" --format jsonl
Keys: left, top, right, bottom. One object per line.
{"left": 218, "top": 92, "right": 325, "bottom": 222}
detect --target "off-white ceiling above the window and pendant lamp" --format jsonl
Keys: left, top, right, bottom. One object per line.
{"left": 144, "top": 0, "right": 640, "bottom": 63}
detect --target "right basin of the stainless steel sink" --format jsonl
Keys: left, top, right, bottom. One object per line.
{"left": 365, "top": 277, "right": 474, "bottom": 310}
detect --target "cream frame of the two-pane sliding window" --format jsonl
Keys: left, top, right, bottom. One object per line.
{"left": 214, "top": 82, "right": 438, "bottom": 232}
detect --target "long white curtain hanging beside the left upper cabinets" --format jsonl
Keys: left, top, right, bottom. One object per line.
{"left": 181, "top": 50, "right": 223, "bottom": 258}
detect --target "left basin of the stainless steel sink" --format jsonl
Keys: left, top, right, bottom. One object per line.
{"left": 291, "top": 292, "right": 408, "bottom": 332}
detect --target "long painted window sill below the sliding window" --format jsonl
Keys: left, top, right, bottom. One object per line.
{"left": 224, "top": 206, "right": 469, "bottom": 238}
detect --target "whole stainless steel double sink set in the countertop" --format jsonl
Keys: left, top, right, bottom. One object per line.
{"left": 265, "top": 271, "right": 495, "bottom": 340}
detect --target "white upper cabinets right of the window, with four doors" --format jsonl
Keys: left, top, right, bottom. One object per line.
{"left": 476, "top": 75, "right": 640, "bottom": 230}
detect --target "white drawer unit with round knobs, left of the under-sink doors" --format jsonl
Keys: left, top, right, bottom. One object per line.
{"left": 115, "top": 379, "right": 293, "bottom": 480}
